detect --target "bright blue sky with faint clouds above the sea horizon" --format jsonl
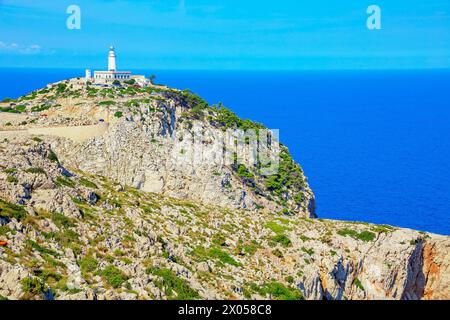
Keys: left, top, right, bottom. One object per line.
{"left": 0, "top": 0, "right": 450, "bottom": 70}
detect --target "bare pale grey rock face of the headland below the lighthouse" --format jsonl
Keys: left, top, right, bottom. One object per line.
{"left": 44, "top": 95, "right": 315, "bottom": 217}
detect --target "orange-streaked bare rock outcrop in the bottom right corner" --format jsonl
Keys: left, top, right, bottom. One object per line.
{"left": 301, "top": 230, "right": 450, "bottom": 300}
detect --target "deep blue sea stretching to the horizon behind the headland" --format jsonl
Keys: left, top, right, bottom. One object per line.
{"left": 0, "top": 69, "right": 450, "bottom": 235}
